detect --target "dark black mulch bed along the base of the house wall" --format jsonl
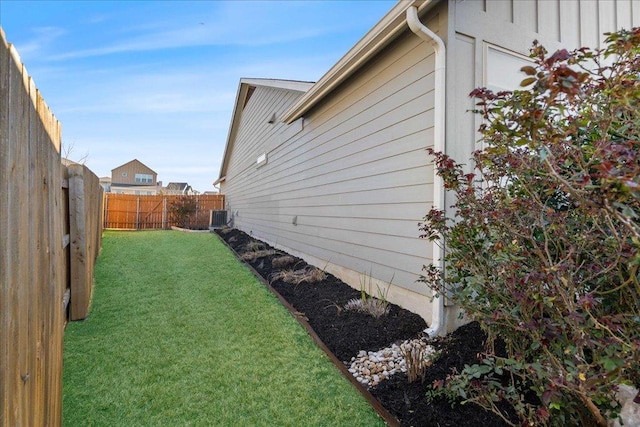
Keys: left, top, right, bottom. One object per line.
{"left": 217, "top": 229, "right": 506, "bottom": 427}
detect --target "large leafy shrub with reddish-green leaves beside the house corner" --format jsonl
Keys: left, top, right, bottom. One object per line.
{"left": 421, "top": 28, "right": 640, "bottom": 426}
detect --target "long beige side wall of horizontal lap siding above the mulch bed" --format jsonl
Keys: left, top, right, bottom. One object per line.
{"left": 221, "top": 5, "right": 447, "bottom": 319}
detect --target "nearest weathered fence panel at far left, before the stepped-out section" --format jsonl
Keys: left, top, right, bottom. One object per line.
{"left": 0, "top": 29, "right": 65, "bottom": 425}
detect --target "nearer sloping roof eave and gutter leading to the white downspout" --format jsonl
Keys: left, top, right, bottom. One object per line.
{"left": 282, "top": 0, "right": 441, "bottom": 123}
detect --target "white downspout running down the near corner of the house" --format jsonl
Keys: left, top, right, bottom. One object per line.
{"left": 407, "top": 6, "right": 447, "bottom": 337}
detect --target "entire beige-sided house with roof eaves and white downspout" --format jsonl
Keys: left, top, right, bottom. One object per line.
{"left": 214, "top": 0, "right": 640, "bottom": 334}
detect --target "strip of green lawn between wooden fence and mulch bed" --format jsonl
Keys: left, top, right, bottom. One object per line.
{"left": 64, "top": 231, "right": 383, "bottom": 426}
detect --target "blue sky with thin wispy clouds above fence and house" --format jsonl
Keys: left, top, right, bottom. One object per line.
{"left": 0, "top": 0, "right": 396, "bottom": 192}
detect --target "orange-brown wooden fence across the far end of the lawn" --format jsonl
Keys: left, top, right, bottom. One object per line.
{"left": 104, "top": 193, "right": 224, "bottom": 230}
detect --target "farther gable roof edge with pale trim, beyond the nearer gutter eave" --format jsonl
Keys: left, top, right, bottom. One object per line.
{"left": 213, "top": 78, "right": 314, "bottom": 185}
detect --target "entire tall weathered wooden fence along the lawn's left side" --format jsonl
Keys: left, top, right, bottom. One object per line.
{"left": 0, "top": 28, "right": 102, "bottom": 426}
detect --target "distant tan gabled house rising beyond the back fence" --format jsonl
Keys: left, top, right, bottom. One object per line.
{"left": 111, "top": 159, "right": 160, "bottom": 195}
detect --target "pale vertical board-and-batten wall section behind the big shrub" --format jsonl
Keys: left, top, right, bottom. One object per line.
{"left": 446, "top": 0, "right": 640, "bottom": 176}
